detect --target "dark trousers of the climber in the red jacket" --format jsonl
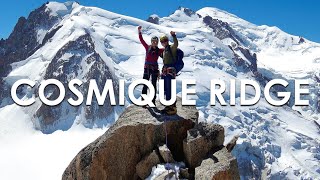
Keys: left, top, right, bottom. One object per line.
{"left": 142, "top": 68, "right": 159, "bottom": 104}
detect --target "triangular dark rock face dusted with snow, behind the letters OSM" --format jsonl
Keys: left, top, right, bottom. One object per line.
{"left": 36, "top": 34, "right": 119, "bottom": 133}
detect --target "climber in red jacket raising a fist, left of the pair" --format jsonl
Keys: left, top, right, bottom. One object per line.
{"left": 138, "top": 26, "right": 163, "bottom": 104}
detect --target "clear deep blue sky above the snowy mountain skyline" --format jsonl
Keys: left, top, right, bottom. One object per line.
{"left": 0, "top": 0, "right": 320, "bottom": 42}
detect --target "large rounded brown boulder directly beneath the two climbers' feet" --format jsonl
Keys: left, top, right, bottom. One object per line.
{"left": 63, "top": 97, "right": 198, "bottom": 179}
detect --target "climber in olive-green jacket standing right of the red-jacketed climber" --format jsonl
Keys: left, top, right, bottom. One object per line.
{"left": 160, "top": 31, "right": 178, "bottom": 115}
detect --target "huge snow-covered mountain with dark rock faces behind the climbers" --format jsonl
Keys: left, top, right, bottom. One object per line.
{"left": 0, "top": 2, "right": 320, "bottom": 179}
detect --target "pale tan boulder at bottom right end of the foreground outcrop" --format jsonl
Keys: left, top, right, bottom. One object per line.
{"left": 195, "top": 148, "right": 240, "bottom": 180}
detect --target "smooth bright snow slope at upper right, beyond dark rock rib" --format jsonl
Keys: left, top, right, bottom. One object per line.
{"left": 197, "top": 7, "right": 320, "bottom": 78}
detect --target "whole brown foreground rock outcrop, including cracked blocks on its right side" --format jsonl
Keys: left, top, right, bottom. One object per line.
{"left": 62, "top": 99, "right": 239, "bottom": 180}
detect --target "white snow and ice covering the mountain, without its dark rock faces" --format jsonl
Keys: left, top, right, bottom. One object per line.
{"left": 0, "top": 2, "right": 320, "bottom": 179}
